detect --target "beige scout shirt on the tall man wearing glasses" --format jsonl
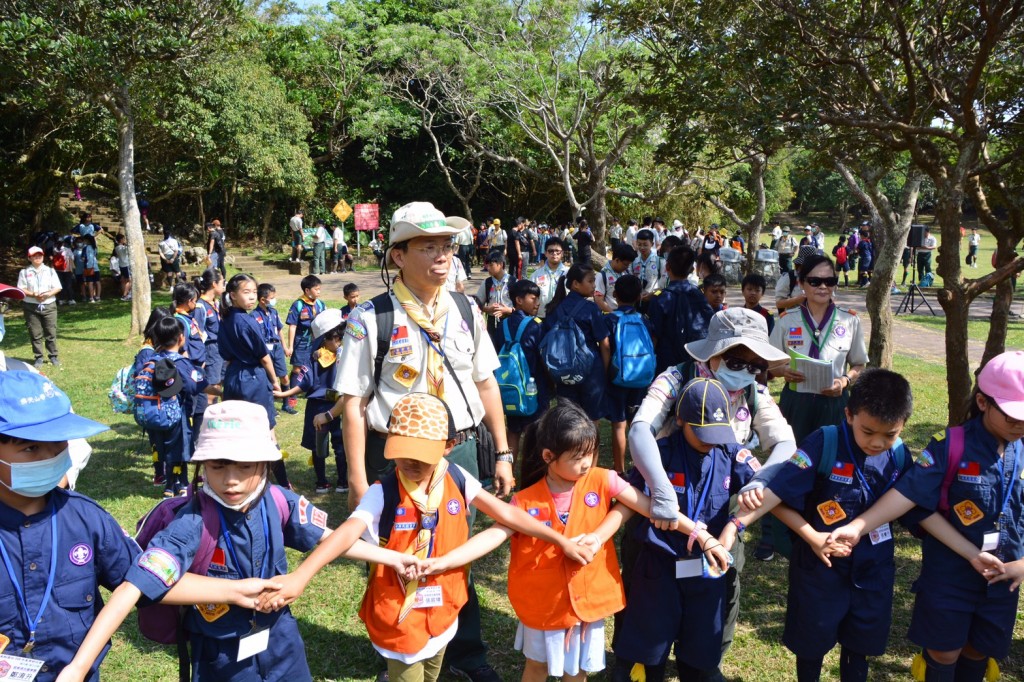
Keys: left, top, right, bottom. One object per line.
{"left": 334, "top": 291, "right": 499, "bottom": 434}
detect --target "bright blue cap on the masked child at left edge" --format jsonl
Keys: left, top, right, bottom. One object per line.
{"left": 0, "top": 372, "right": 110, "bottom": 442}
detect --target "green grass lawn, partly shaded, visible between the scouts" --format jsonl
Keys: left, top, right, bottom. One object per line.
{"left": 3, "top": 295, "right": 1024, "bottom": 682}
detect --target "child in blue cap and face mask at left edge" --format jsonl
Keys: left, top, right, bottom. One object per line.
{"left": 0, "top": 372, "right": 139, "bottom": 682}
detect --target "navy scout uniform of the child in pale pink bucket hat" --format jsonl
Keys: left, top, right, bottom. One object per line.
{"left": 126, "top": 485, "right": 327, "bottom": 682}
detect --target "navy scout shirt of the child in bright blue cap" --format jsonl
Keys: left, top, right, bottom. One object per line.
{"left": 0, "top": 488, "right": 140, "bottom": 682}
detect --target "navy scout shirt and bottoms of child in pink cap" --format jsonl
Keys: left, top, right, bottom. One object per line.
{"left": 896, "top": 416, "right": 1024, "bottom": 658}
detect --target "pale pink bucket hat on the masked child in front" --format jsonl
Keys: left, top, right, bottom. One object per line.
{"left": 191, "top": 400, "right": 281, "bottom": 462}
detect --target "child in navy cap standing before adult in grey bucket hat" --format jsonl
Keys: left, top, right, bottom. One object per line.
{"left": 611, "top": 379, "right": 759, "bottom": 682}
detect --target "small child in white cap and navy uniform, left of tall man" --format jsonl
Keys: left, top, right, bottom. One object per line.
{"left": 282, "top": 308, "right": 348, "bottom": 495}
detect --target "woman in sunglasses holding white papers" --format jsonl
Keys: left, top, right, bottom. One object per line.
{"left": 771, "top": 255, "right": 867, "bottom": 443}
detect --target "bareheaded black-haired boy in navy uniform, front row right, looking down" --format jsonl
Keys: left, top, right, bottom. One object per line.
{"left": 720, "top": 370, "right": 913, "bottom": 682}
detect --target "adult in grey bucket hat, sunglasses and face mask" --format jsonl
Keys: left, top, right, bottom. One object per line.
{"left": 622, "top": 308, "right": 797, "bottom": 679}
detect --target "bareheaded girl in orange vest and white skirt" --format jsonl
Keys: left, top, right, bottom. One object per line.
{"left": 426, "top": 399, "right": 728, "bottom": 682}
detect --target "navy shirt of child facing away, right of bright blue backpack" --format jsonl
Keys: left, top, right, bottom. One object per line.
{"left": 646, "top": 280, "right": 715, "bottom": 374}
